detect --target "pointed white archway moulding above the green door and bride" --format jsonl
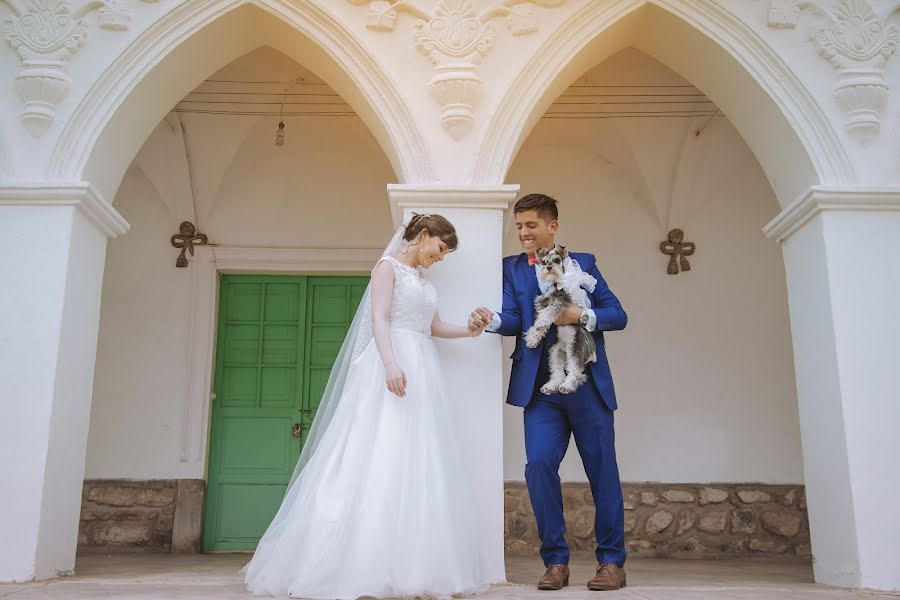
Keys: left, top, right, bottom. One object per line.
{"left": 48, "top": 0, "right": 432, "bottom": 200}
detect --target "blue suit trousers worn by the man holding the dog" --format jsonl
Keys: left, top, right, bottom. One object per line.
{"left": 525, "top": 358, "right": 626, "bottom": 567}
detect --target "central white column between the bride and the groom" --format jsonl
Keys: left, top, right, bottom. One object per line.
{"left": 388, "top": 185, "right": 519, "bottom": 581}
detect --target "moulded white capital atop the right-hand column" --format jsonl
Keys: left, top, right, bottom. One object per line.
{"left": 763, "top": 185, "right": 900, "bottom": 242}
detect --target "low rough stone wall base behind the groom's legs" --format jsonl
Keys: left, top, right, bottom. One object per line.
{"left": 505, "top": 482, "right": 811, "bottom": 560}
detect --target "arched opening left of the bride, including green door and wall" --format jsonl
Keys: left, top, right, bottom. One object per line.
{"left": 80, "top": 46, "right": 395, "bottom": 552}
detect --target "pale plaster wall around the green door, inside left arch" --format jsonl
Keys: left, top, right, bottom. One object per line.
{"left": 85, "top": 50, "right": 395, "bottom": 479}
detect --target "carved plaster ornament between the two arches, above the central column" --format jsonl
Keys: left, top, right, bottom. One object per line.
{"left": 348, "top": 0, "right": 565, "bottom": 139}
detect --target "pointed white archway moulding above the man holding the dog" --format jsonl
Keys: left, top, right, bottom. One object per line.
{"left": 475, "top": 0, "right": 854, "bottom": 206}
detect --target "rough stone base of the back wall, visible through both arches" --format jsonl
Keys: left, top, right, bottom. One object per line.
{"left": 78, "top": 479, "right": 810, "bottom": 559}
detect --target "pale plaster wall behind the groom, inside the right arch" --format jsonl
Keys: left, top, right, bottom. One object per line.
{"left": 505, "top": 50, "right": 803, "bottom": 483}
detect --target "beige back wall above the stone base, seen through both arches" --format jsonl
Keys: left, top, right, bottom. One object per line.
{"left": 86, "top": 48, "right": 802, "bottom": 483}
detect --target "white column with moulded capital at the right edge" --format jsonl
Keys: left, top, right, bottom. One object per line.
{"left": 766, "top": 187, "right": 900, "bottom": 590}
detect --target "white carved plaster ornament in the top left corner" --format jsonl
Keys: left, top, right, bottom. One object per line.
{"left": 0, "top": 0, "right": 155, "bottom": 136}
